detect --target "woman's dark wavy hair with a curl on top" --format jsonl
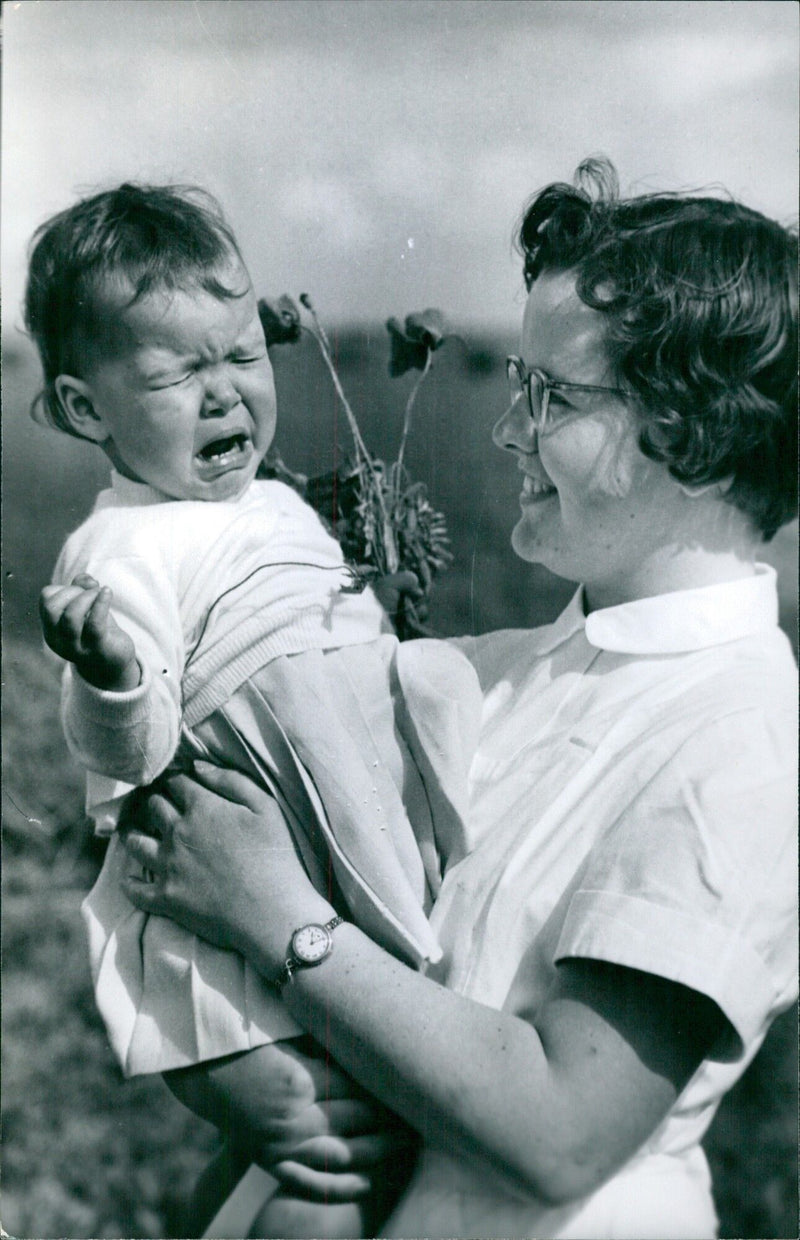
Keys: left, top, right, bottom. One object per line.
{"left": 518, "top": 160, "right": 798, "bottom": 539}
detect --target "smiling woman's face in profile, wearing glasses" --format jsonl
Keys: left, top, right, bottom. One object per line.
{"left": 492, "top": 272, "right": 681, "bottom": 606}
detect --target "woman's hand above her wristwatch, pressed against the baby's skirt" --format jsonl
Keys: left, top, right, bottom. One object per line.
{"left": 119, "top": 763, "right": 334, "bottom": 978}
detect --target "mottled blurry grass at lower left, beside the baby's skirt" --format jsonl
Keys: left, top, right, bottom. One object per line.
{"left": 2, "top": 641, "right": 215, "bottom": 1238}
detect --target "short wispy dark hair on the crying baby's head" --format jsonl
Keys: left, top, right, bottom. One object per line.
{"left": 24, "top": 184, "right": 246, "bottom": 438}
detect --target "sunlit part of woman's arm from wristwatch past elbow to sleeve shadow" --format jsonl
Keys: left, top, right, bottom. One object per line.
{"left": 249, "top": 925, "right": 675, "bottom": 1204}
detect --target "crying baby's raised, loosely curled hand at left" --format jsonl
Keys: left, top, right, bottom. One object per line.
{"left": 38, "top": 573, "right": 141, "bottom": 693}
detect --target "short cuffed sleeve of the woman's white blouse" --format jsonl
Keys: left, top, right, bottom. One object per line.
{"left": 556, "top": 709, "right": 798, "bottom": 1044}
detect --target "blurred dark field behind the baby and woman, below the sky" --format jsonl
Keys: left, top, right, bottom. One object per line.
{"left": 2, "top": 329, "right": 798, "bottom": 1238}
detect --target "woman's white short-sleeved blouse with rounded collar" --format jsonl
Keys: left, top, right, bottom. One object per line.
{"left": 384, "top": 565, "right": 798, "bottom": 1240}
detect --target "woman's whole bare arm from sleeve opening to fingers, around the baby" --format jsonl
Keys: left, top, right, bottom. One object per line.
{"left": 128, "top": 764, "right": 723, "bottom": 1204}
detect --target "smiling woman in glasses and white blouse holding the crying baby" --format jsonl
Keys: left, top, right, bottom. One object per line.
{"left": 117, "top": 164, "right": 796, "bottom": 1240}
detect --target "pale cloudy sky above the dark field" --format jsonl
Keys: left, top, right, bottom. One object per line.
{"left": 2, "top": 0, "right": 799, "bottom": 334}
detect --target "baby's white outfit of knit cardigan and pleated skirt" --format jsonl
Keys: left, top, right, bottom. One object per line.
{"left": 56, "top": 475, "right": 480, "bottom": 1075}
